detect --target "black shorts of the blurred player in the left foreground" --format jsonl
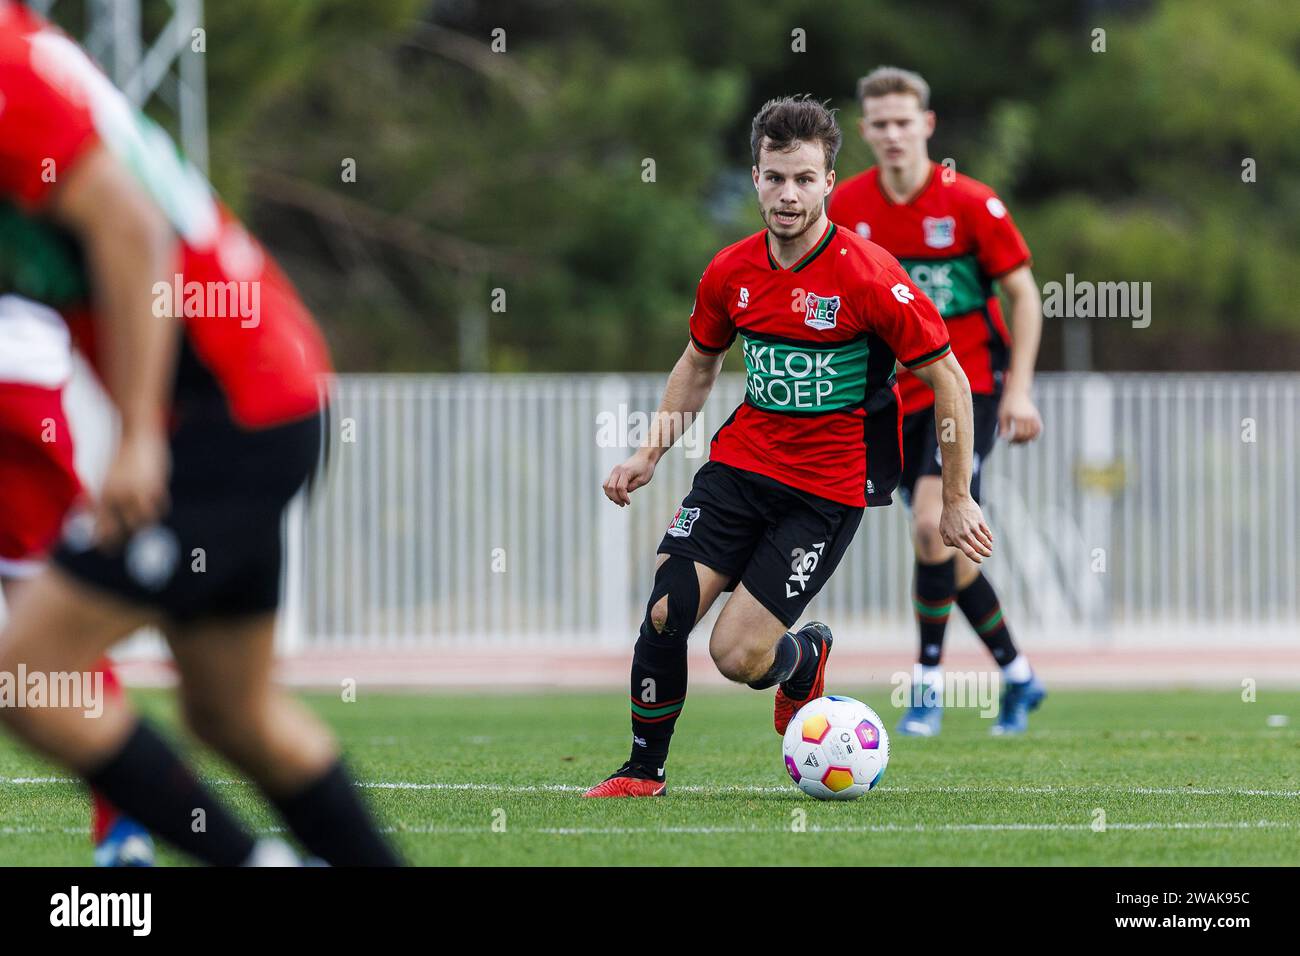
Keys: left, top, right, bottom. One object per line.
{"left": 52, "top": 406, "right": 322, "bottom": 622}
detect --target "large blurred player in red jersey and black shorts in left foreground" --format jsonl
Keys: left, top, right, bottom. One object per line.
{"left": 0, "top": 0, "right": 395, "bottom": 865}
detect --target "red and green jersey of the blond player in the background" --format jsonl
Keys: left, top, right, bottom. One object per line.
{"left": 827, "top": 163, "right": 1030, "bottom": 415}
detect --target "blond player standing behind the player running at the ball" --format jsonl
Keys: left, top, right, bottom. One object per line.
{"left": 829, "top": 66, "right": 1044, "bottom": 736}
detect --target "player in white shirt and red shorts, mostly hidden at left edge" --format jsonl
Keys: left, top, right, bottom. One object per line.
{"left": 0, "top": 295, "right": 153, "bottom": 866}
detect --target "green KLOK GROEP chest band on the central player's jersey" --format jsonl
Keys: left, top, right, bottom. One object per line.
{"left": 741, "top": 332, "right": 871, "bottom": 412}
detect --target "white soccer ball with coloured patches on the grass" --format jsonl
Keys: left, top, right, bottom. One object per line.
{"left": 781, "top": 697, "right": 889, "bottom": 800}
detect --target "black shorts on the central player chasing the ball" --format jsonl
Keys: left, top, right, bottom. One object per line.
{"left": 659, "top": 462, "right": 863, "bottom": 627}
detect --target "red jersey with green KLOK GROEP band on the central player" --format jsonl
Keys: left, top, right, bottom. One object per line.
{"left": 690, "top": 224, "right": 949, "bottom": 507}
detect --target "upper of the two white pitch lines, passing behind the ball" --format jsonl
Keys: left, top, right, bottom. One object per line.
{"left": 0, "top": 777, "right": 1300, "bottom": 797}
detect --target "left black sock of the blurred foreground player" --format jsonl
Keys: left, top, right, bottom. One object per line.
{"left": 86, "top": 721, "right": 255, "bottom": 866}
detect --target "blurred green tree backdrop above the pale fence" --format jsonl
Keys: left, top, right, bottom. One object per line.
{"left": 83, "top": 0, "right": 1300, "bottom": 371}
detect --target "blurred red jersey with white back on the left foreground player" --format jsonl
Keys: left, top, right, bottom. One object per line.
{"left": 0, "top": 0, "right": 330, "bottom": 428}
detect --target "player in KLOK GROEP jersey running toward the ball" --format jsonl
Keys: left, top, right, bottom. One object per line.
{"left": 586, "top": 98, "right": 992, "bottom": 797}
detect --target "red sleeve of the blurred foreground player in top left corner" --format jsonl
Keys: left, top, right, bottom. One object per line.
{"left": 0, "top": 35, "right": 98, "bottom": 208}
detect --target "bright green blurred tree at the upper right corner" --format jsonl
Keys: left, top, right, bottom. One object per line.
{"left": 1021, "top": 0, "right": 1300, "bottom": 368}
